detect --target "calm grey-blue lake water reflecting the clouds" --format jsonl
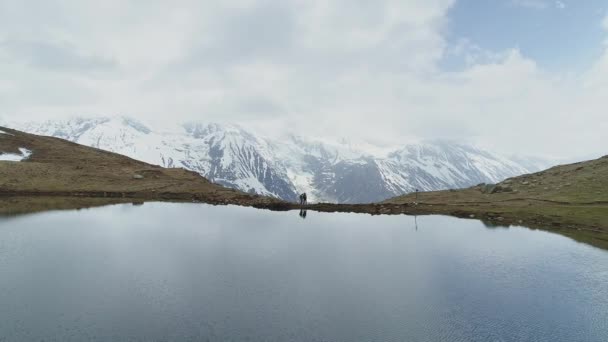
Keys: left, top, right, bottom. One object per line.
{"left": 0, "top": 203, "right": 608, "bottom": 342}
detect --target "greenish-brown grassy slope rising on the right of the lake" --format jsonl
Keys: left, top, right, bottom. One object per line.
{"left": 382, "top": 156, "right": 608, "bottom": 231}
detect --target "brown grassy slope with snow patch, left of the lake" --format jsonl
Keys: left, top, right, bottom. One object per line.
{"left": 0, "top": 127, "right": 279, "bottom": 205}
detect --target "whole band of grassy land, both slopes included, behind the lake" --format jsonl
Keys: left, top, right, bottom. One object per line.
{"left": 0, "top": 128, "right": 608, "bottom": 245}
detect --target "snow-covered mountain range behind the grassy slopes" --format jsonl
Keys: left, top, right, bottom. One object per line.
{"left": 7, "top": 117, "right": 548, "bottom": 203}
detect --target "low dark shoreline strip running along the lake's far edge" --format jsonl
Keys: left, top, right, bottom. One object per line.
{"left": 0, "top": 191, "right": 608, "bottom": 249}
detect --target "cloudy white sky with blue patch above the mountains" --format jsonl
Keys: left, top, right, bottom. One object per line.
{"left": 0, "top": 0, "right": 608, "bottom": 158}
